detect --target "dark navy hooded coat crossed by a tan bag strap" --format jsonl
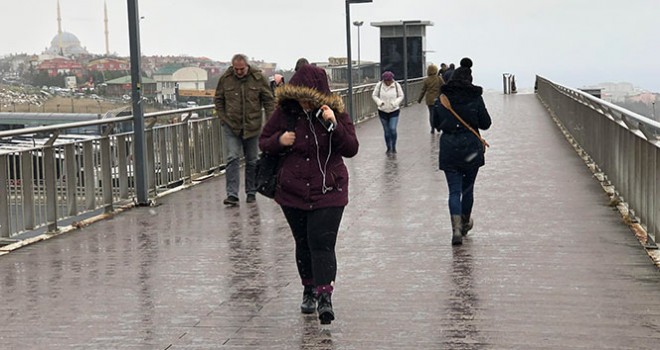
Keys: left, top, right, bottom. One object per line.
{"left": 433, "top": 80, "right": 492, "bottom": 170}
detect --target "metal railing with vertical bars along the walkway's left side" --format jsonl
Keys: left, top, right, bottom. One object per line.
{"left": 0, "top": 79, "right": 422, "bottom": 240}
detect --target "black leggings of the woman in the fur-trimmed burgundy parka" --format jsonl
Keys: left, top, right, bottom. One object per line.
{"left": 282, "top": 207, "right": 344, "bottom": 286}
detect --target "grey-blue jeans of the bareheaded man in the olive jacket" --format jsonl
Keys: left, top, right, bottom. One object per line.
{"left": 222, "top": 125, "right": 259, "bottom": 198}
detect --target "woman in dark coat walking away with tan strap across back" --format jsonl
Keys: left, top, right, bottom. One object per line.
{"left": 434, "top": 57, "right": 492, "bottom": 245}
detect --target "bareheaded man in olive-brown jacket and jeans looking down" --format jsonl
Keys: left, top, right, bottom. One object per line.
{"left": 214, "top": 54, "right": 275, "bottom": 206}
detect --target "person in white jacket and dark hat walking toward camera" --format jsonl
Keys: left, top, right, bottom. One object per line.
{"left": 371, "top": 71, "right": 403, "bottom": 154}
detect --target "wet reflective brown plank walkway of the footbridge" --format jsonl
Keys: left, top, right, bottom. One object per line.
{"left": 0, "top": 93, "right": 660, "bottom": 350}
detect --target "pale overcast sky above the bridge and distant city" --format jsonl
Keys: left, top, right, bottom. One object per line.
{"left": 0, "top": 0, "right": 660, "bottom": 92}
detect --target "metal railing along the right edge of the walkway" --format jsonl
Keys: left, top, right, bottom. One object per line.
{"left": 536, "top": 76, "right": 660, "bottom": 241}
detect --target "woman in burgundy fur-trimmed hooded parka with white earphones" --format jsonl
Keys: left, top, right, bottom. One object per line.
{"left": 259, "top": 65, "right": 359, "bottom": 324}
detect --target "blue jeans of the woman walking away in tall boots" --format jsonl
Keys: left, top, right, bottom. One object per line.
{"left": 445, "top": 168, "right": 479, "bottom": 215}
